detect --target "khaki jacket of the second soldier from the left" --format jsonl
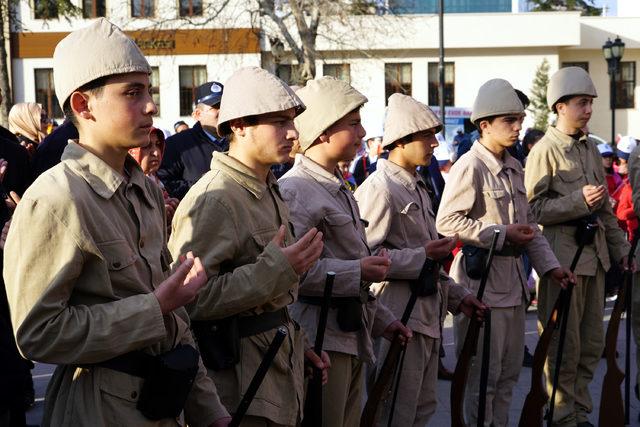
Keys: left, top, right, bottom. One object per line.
{"left": 169, "top": 153, "right": 304, "bottom": 425}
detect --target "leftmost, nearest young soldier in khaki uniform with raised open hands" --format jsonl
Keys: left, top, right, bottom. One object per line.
{"left": 4, "top": 19, "right": 229, "bottom": 426}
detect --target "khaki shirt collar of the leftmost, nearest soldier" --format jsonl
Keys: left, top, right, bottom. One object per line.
{"left": 61, "top": 139, "right": 153, "bottom": 206}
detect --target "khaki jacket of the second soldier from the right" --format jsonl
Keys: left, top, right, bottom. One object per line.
{"left": 436, "top": 142, "right": 560, "bottom": 307}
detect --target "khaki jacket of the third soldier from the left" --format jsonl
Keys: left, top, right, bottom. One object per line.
{"left": 279, "top": 154, "right": 396, "bottom": 362}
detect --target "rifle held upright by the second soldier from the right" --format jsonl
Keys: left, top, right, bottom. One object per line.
{"left": 450, "top": 230, "right": 500, "bottom": 427}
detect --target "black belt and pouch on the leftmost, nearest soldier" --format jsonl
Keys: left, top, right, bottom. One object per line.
{"left": 80, "top": 344, "right": 199, "bottom": 421}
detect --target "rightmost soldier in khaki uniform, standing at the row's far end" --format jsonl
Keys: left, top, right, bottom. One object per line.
{"left": 525, "top": 67, "right": 629, "bottom": 426}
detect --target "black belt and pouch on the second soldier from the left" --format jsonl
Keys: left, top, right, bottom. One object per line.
{"left": 191, "top": 307, "right": 289, "bottom": 371}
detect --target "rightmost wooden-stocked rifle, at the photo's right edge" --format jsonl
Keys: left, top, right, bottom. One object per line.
{"left": 599, "top": 234, "right": 640, "bottom": 426}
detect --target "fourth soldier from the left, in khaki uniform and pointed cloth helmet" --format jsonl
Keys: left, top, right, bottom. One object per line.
{"left": 355, "top": 93, "right": 483, "bottom": 427}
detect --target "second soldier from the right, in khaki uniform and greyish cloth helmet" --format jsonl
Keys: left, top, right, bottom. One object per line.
{"left": 437, "top": 79, "right": 570, "bottom": 426}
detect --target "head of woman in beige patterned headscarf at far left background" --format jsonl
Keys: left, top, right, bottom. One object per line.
{"left": 9, "top": 102, "right": 49, "bottom": 154}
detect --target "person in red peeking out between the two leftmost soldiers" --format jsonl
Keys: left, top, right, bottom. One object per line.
{"left": 129, "top": 128, "right": 180, "bottom": 227}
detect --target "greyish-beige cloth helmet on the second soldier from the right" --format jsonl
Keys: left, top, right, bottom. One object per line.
{"left": 471, "top": 79, "right": 524, "bottom": 123}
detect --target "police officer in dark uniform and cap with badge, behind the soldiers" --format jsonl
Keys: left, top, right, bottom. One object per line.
{"left": 158, "top": 82, "right": 229, "bottom": 199}
